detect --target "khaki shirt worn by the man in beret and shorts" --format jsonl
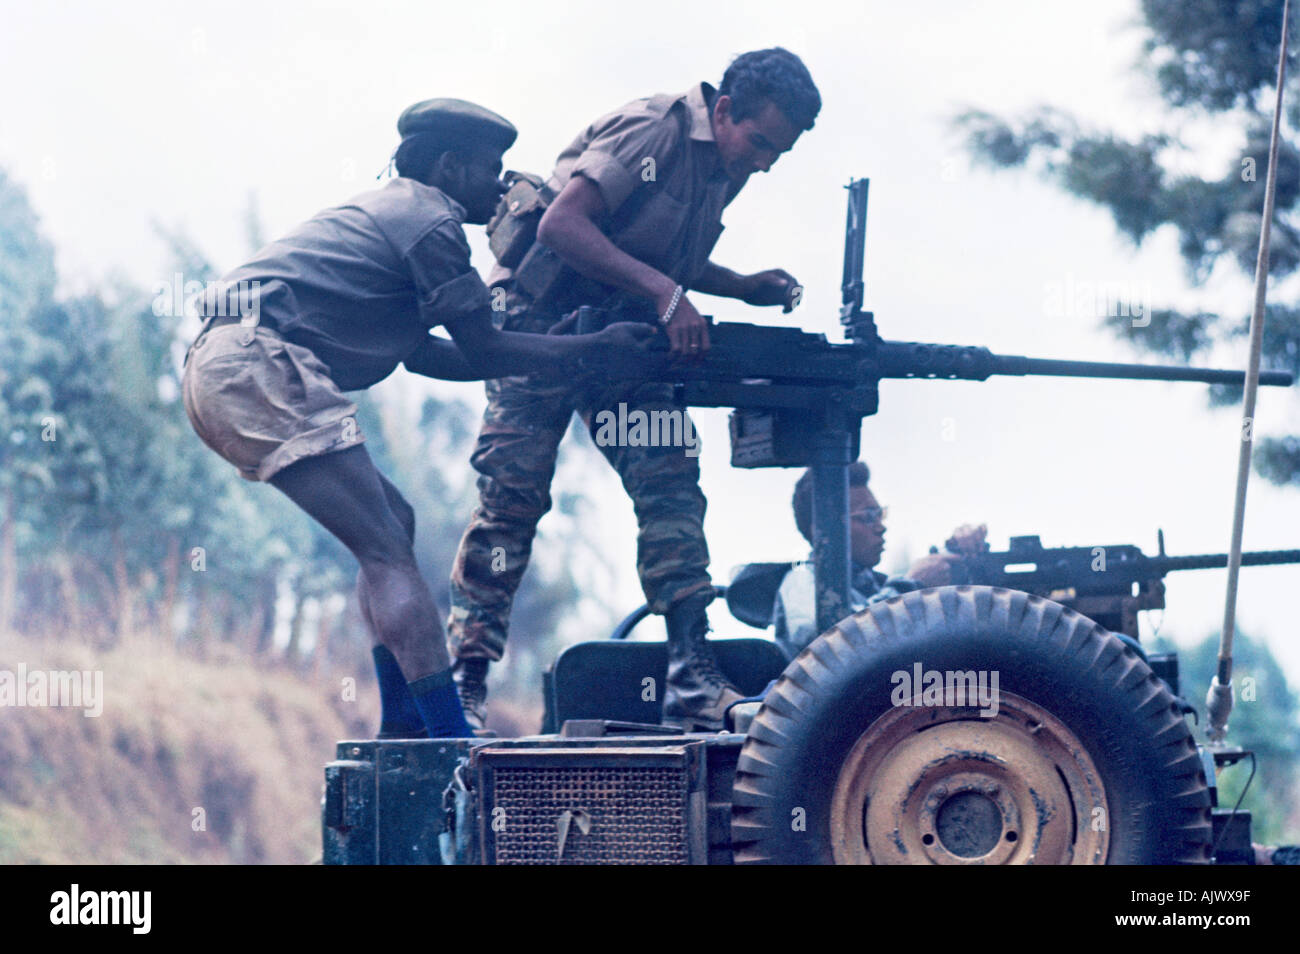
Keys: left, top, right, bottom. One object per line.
{"left": 199, "top": 177, "right": 489, "bottom": 391}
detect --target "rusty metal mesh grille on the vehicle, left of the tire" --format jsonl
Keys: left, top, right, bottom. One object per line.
{"left": 488, "top": 766, "right": 689, "bottom": 864}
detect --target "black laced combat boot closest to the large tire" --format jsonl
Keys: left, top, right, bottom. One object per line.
{"left": 663, "top": 593, "right": 744, "bottom": 732}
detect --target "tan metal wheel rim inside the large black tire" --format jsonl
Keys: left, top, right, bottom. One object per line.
{"left": 831, "top": 691, "right": 1109, "bottom": 864}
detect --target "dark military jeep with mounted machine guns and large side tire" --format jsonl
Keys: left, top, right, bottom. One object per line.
{"left": 322, "top": 179, "right": 1300, "bottom": 864}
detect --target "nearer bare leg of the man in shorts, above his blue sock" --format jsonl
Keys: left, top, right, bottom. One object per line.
{"left": 270, "top": 445, "right": 451, "bottom": 682}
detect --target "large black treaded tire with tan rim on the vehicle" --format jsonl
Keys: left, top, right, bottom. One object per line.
{"left": 732, "top": 586, "right": 1212, "bottom": 864}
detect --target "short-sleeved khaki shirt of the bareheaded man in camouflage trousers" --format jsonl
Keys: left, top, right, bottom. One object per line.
{"left": 514, "top": 83, "right": 738, "bottom": 305}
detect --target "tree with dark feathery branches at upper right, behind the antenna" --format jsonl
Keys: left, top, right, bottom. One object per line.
{"left": 956, "top": 0, "right": 1300, "bottom": 485}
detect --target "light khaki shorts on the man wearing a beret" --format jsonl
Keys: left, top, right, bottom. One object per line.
{"left": 182, "top": 324, "right": 365, "bottom": 481}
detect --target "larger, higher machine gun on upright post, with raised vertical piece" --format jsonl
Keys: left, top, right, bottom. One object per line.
{"left": 573, "top": 179, "right": 1292, "bottom": 642}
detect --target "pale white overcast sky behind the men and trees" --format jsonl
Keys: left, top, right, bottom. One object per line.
{"left": 0, "top": 0, "right": 1300, "bottom": 699}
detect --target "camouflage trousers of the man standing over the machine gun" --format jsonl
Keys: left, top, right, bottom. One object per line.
{"left": 447, "top": 314, "right": 712, "bottom": 659}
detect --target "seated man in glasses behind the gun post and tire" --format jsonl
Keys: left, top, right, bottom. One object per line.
{"left": 772, "top": 460, "right": 988, "bottom": 659}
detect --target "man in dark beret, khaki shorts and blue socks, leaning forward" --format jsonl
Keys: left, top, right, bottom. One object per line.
{"left": 183, "top": 99, "right": 653, "bottom": 737}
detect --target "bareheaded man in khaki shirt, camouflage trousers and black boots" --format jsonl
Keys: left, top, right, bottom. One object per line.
{"left": 449, "top": 49, "right": 820, "bottom": 729}
